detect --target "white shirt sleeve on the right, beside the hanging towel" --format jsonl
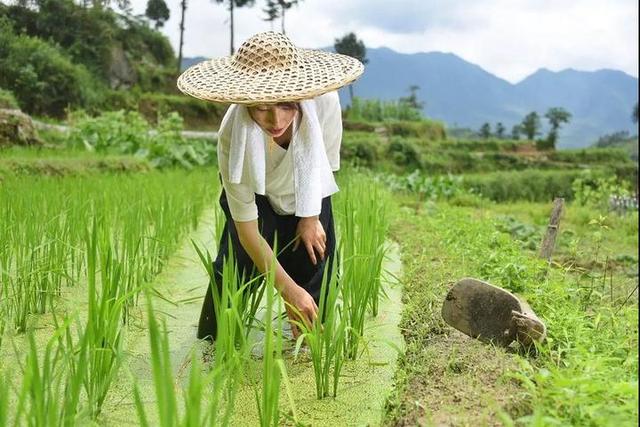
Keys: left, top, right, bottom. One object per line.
{"left": 318, "top": 91, "right": 342, "bottom": 171}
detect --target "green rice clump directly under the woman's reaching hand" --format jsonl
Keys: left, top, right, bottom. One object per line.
{"left": 296, "top": 257, "right": 347, "bottom": 399}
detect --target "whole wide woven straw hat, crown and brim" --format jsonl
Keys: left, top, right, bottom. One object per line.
{"left": 178, "top": 31, "right": 364, "bottom": 104}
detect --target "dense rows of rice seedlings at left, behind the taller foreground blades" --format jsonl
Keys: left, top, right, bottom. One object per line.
{"left": 0, "top": 171, "right": 218, "bottom": 332}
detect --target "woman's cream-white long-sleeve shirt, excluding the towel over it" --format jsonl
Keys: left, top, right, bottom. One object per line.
{"left": 218, "top": 91, "right": 342, "bottom": 221}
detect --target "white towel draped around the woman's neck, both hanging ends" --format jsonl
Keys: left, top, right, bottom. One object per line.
{"left": 225, "top": 100, "right": 338, "bottom": 217}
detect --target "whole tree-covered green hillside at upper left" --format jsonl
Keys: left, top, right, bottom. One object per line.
{"left": 0, "top": 0, "right": 176, "bottom": 117}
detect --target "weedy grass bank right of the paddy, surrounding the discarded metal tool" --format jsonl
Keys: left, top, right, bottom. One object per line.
{"left": 387, "top": 193, "right": 638, "bottom": 425}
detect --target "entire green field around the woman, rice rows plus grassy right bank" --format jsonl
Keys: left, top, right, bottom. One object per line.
{"left": 0, "top": 132, "right": 638, "bottom": 426}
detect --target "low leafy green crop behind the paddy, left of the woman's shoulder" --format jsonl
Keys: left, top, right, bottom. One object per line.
{"left": 68, "top": 110, "right": 215, "bottom": 168}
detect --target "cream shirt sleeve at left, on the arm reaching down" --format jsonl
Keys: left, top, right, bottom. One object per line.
{"left": 217, "top": 125, "right": 258, "bottom": 222}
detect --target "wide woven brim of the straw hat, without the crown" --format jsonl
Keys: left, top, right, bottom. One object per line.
{"left": 177, "top": 48, "right": 364, "bottom": 104}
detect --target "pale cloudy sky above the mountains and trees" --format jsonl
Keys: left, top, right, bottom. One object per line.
{"left": 132, "top": 0, "right": 638, "bottom": 83}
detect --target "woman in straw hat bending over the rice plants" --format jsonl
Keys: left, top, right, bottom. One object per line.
{"left": 178, "top": 32, "right": 364, "bottom": 340}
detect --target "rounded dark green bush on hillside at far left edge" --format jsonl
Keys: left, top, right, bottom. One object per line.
{"left": 0, "top": 17, "right": 99, "bottom": 117}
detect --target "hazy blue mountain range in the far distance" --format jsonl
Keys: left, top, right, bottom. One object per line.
{"left": 183, "top": 48, "right": 638, "bottom": 148}
